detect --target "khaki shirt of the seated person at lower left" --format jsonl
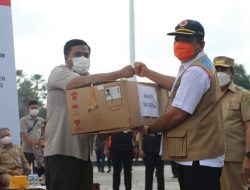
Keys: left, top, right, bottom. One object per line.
{"left": 0, "top": 144, "right": 31, "bottom": 174}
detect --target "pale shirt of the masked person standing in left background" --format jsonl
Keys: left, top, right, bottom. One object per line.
{"left": 20, "top": 115, "right": 43, "bottom": 153}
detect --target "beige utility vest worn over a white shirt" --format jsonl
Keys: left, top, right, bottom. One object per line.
{"left": 162, "top": 56, "right": 224, "bottom": 161}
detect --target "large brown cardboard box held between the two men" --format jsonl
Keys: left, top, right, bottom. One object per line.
{"left": 67, "top": 81, "right": 168, "bottom": 134}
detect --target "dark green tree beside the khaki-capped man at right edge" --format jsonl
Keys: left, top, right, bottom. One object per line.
{"left": 234, "top": 64, "right": 250, "bottom": 90}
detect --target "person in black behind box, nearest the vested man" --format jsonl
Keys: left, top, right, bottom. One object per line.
{"left": 139, "top": 133, "right": 165, "bottom": 190}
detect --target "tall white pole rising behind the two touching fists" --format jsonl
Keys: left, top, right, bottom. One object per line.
{"left": 129, "top": 0, "right": 136, "bottom": 81}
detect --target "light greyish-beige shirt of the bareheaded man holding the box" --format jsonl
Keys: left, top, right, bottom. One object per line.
{"left": 44, "top": 65, "right": 95, "bottom": 160}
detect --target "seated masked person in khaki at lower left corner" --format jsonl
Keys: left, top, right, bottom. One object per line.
{"left": 0, "top": 128, "right": 31, "bottom": 188}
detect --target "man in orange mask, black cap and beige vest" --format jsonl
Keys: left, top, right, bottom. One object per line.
{"left": 135, "top": 20, "right": 224, "bottom": 190}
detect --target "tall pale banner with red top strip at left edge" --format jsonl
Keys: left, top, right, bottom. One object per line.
{"left": 0, "top": 0, "right": 20, "bottom": 144}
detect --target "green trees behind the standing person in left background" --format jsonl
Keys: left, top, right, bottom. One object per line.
{"left": 16, "top": 70, "right": 47, "bottom": 118}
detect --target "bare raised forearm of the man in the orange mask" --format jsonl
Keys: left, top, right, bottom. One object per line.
{"left": 147, "top": 70, "right": 175, "bottom": 91}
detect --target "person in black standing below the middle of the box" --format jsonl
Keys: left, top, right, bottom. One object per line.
{"left": 105, "top": 131, "right": 138, "bottom": 190}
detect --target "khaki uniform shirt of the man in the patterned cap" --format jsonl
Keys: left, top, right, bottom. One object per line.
{"left": 222, "top": 82, "right": 250, "bottom": 162}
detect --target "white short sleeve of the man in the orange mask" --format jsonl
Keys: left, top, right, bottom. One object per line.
{"left": 172, "top": 66, "right": 210, "bottom": 114}
